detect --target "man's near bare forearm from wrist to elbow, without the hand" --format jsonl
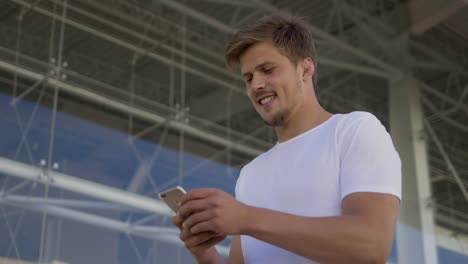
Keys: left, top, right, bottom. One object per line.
{"left": 245, "top": 207, "right": 386, "bottom": 263}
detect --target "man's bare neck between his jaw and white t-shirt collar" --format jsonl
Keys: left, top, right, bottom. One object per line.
{"left": 275, "top": 100, "right": 332, "bottom": 143}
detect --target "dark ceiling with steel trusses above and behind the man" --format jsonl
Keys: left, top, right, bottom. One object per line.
{"left": 0, "top": 0, "right": 468, "bottom": 256}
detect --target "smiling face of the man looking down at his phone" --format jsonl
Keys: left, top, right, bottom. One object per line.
{"left": 240, "top": 42, "right": 304, "bottom": 126}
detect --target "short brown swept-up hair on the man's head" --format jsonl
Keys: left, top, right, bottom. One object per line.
{"left": 225, "top": 16, "right": 317, "bottom": 86}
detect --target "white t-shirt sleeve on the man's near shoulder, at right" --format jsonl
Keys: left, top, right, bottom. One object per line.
{"left": 339, "top": 113, "right": 401, "bottom": 199}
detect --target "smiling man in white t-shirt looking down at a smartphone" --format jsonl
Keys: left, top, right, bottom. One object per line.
{"left": 173, "top": 16, "right": 401, "bottom": 263}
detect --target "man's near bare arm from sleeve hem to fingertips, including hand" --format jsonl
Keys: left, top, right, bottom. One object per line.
{"left": 180, "top": 189, "right": 400, "bottom": 263}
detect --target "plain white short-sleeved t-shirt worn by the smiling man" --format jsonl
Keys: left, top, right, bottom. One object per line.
{"left": 236, "top": 112, "right": 401, "bottom": 264}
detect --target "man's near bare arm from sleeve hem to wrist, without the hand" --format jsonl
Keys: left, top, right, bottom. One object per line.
{"left": 245, "top": 193, "right": 399, "bottom": 263}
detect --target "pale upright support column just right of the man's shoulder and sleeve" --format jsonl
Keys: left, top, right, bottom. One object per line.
{"left": 389, "top": 35, "right": 438, "bottom": 264}
